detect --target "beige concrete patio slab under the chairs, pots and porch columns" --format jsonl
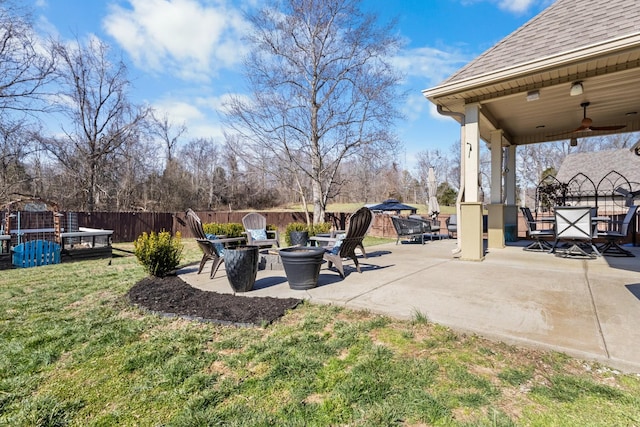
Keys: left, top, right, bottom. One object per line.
{"left": 179, "top": 240, "right": 640, "bottom": 372}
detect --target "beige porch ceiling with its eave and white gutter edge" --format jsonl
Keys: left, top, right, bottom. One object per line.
{"left": 423, "top": 41, "right": 640, "bottom": 145}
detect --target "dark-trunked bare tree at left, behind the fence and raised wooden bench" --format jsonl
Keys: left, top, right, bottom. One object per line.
{"left": 42, "top": 38, "right": 148, "bottom": 212}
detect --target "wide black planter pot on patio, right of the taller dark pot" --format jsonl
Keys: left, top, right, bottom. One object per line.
{"left": 280, "top": 246, "right": 324, "bottom": 290}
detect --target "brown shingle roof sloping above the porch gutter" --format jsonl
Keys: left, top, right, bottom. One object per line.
{"left": 443, "top": 0, "right": 640, "bottom": 84}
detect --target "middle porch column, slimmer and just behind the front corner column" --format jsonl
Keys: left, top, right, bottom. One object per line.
{"left": 487, "top": 130, "right": 505, "bottom": 249}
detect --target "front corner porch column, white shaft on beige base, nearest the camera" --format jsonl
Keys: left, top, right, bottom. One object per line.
{"left": 458, "top": 103, "right": 484, "bottom": 261}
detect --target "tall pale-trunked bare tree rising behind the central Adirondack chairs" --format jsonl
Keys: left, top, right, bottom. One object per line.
{"left": 227, "top": 0, "right": 401, "bottom": 226}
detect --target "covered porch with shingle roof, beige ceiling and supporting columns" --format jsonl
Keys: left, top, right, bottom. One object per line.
{"left": 423, "top": 0, "right": 640, "bottom": 261}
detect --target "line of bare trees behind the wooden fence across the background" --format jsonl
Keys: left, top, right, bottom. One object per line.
{"left": 0, "top": 0, "right": 635, "bottom": 218}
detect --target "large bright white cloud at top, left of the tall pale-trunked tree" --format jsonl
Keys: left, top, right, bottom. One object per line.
{"left": 103, "top": 0, "right": 246, "bottom": 81}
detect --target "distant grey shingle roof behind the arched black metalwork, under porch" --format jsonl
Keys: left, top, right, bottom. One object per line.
{"left": 556, "top": 148, "right": 640, "bottom": 188}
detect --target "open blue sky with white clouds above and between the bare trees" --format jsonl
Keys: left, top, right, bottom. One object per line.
{"left": 30, "top": 0, "right": 553, "bottom": 168}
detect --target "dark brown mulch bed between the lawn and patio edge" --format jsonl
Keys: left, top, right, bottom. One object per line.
{"left": 128, "top": 276, "right": 302, "bottom": 326}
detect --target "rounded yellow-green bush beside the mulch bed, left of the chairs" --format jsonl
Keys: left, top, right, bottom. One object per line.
{"left": 133, "top": 231, "right": 183, "bottom": 277}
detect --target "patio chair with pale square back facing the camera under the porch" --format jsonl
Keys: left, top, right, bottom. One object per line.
{"left": 549, "top": 206, "right": 600, "bottom": 258}
